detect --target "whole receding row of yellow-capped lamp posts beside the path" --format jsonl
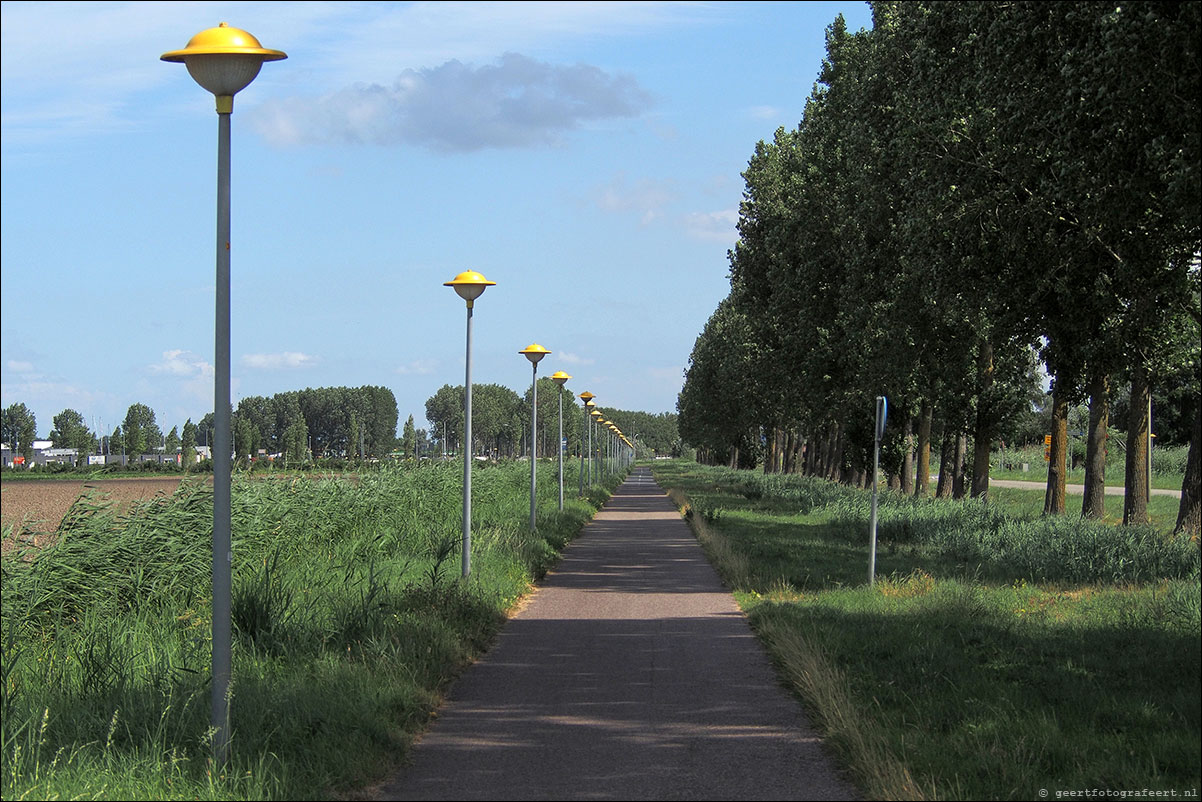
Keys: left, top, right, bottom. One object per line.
{"left": 160, "top": 23, "right": 644, "bottom": 765}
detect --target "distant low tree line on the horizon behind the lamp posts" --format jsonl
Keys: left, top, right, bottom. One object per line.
{"left": 0, "top": 379, "right": 680, "bottom": 468}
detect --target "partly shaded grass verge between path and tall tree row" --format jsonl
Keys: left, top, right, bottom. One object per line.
{"left": 654, "top": 463, "right": 1202, "bottom": 800}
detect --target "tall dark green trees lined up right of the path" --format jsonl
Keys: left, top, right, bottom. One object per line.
{"left": 679, "top": 1, "right": 1202, "bottom": 531}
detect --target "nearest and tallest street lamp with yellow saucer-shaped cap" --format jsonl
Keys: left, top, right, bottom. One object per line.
{"left": 159, "top": 23, "right": 287, "bottom": 764}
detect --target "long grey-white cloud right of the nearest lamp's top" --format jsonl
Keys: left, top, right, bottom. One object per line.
{"left": 251, "top": 53, "right": 650, "bottom": 153}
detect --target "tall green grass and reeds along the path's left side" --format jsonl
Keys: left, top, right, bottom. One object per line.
{"left": 2, "top": 464, "right": 608, "bottom": 800}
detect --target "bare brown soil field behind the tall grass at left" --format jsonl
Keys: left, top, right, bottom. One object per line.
{"left": 0, "top": 476, "right": 179, "bottom": 554}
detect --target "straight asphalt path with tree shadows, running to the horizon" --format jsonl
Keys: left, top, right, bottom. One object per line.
{"left": 376, "top": 469, "right": 856, "bottom": 800}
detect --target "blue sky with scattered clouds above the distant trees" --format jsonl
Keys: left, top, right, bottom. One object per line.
{"left": 0, "top": 2, "right": 870, "bottom": 436}
